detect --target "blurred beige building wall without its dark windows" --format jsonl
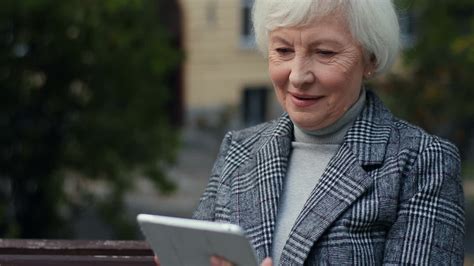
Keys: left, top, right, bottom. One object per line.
{"left": 179, "top": 0, "right": 270, "bottom": 110}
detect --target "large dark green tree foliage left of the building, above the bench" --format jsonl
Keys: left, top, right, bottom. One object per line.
{"left": 0, "top": 0, "right": 181, "bottom": 238}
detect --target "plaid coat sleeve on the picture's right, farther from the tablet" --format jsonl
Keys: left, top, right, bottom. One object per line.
{"left": 384, "top": 139, "right": 464, "bottom": 265}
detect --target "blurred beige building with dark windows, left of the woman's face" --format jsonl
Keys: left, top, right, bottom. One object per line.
{"left": 176, "top": 0, "right": 281, "bottom": 128}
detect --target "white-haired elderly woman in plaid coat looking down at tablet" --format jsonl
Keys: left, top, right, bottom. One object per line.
{"left": 194, "top": 0, "right": 464, "bottom": 265}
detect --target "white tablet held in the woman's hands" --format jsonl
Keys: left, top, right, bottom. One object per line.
{"left": 137, "top": 214, "right": 258, "bottom": 266}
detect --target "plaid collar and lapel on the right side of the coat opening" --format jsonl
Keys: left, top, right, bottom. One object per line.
{"left": 280, "top": 91, "right": 391, "bottom": 265}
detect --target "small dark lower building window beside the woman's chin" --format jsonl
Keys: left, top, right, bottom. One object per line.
{"left": 242, "top": 86, "right": 269, "bottom": 126}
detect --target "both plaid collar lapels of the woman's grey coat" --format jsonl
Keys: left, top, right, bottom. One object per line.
{"left": 252, "top": 91, "right": 392, "bottom": 264}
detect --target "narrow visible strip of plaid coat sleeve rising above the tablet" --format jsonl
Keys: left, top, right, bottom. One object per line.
{"left": 193, "top": 132, "right": 232, "bottom": 221}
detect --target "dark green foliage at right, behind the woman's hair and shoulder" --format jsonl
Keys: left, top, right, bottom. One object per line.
{"left": 382, "top": 0, "right": 474, "bottom": 161}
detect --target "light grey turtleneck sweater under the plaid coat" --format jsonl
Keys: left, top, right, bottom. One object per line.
{"left": 272, "top": 89, "right": 366, "bottom": 265}
